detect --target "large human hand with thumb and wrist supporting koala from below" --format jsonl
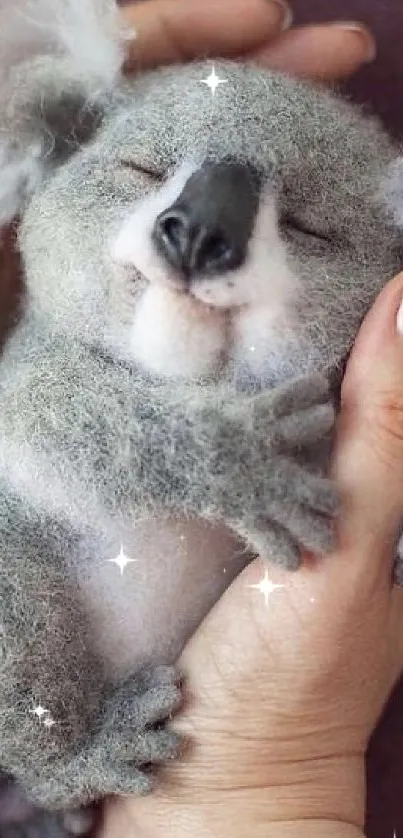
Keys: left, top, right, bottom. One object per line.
{"left": 102, "top": 274, "right": 403, "bottom": 838}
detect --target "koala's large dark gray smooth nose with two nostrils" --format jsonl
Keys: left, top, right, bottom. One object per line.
{"left": 153, "top": 162, "right": 259, "bottom": 279}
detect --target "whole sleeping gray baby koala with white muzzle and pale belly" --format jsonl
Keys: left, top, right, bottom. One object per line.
{"left": 0, "top": 0, "right": 402, "bottom": 835}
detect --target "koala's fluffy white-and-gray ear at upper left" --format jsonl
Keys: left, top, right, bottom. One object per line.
{"left": 0, "top": 0, "right": 129, "bottom": 226}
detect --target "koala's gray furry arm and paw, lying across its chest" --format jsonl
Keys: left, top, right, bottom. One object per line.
{"left": 3, "top": 340, "right": 337, "bottom": 567}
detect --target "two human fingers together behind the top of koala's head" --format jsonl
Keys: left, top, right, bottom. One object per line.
{"left": 123, "top": 0, "right": 375, "bottom": 81}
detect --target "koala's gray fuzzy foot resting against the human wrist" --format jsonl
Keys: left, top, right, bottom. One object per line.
{"left": 25, "top": 666, "right": 182, "bottom": 810}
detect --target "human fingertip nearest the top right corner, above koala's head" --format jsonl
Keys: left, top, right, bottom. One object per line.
{"left": 252, "top": 23, "right": 376, "bottom": 82}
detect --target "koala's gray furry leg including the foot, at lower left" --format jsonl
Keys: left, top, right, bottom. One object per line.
{"left": 0, "top": 490, "right": 180, "bottom": 809}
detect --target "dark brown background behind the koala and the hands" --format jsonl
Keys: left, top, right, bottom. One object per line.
{"left": 0, "top": 0, "right": 403, "bottom": 838}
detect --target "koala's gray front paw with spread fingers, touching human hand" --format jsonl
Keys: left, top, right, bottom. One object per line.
{"left": 204, "top": 375, "right": 339, "bottom": 568}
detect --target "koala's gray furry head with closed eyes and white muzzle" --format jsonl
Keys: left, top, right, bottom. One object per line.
{"left": 0, "top": 0, "right": 401, "bottom": 382}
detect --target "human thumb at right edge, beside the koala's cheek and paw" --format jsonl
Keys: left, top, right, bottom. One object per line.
{"left": 335, "top": 274, "right": 403, "bottom": 579}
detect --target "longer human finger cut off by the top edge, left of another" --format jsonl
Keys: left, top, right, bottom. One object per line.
{"left": 122, "top": 0, "right": 291, "bottom": 70}
